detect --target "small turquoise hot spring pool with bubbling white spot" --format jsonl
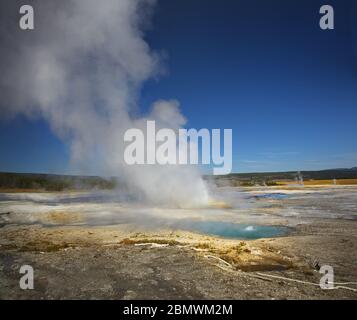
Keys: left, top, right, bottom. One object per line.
{"left": 182, "top": 221, "right": 288, "bottom": 240}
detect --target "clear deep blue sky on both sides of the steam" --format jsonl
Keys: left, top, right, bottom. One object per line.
{"left": 0, "top": 0, "right": 357, "bottom": 173}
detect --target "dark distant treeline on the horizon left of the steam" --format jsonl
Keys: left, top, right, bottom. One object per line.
{"left": 0, "top": 173, "right": 116, "bottom": 191}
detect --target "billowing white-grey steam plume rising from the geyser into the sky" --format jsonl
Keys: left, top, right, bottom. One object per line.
{"left": 0, "top": 0, "right": 207, "bottom": 206}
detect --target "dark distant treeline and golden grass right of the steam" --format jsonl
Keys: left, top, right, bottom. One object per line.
{"left": 206, "top": 167, "right": 357, "bottom": 186}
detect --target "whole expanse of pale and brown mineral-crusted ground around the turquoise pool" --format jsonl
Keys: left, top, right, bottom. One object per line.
{"left": 0, "top": 186, "right": 357, "bottom": 299}
